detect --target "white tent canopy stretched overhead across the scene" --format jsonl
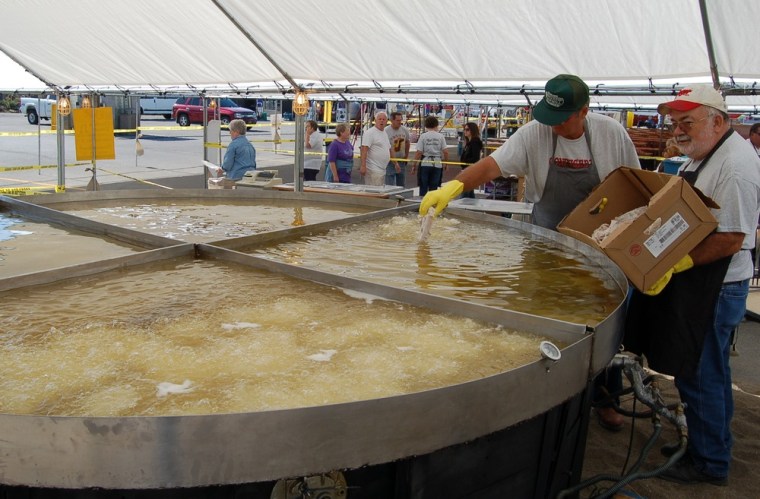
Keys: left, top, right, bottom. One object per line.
{"left": 0, "top": 0, "right": 760, "bottom": 108}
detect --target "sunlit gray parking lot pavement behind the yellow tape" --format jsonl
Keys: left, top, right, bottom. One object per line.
{"left": 0, "top": 113, "right": 295, "bottom": 192}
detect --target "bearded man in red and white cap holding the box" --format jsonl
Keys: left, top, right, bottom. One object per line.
{"left": 624, "top": 85, "right": 760, "bottom": 485}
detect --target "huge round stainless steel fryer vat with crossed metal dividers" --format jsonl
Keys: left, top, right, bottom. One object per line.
{"left": 0, "top": 190, "right": 627, "bottom": 497}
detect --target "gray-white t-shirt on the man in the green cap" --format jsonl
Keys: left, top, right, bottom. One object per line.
{"left": 491, "top": 113, "right": 641, "bottom": 203}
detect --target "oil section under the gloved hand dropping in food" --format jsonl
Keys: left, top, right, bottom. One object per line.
{"left": 243, "top": 214, "right": 623, "bottom": 324}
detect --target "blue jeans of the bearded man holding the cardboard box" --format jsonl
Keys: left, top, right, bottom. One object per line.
{"left": 675, "top": 279, "right": 749, "bottom": 477}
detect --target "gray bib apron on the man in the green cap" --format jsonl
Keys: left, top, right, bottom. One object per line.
{"left": 531, "top": 123, "right": 599, "bottom": 230}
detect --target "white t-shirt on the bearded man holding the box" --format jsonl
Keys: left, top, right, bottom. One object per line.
{"left": 681, "top": 132, "right": 760, "bottom": 282}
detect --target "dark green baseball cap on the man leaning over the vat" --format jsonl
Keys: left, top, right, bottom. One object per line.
{"left": 533, "top": 75, "right": 589, "bottom": 126}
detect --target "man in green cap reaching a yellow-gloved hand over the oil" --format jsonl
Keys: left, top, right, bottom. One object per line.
{"left": 420, "top": 74, "right": 640, "bottom": 431}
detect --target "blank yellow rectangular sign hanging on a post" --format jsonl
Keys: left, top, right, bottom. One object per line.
{"left": 72, "top": 107, "right": 116, "bottom": 161}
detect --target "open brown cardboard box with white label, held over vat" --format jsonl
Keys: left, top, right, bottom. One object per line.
{"left": 557, "top": 167, "right": 719, "bottom": 291}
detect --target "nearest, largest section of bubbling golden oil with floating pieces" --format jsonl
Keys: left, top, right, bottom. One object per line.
{"left": 0, "top": 261, "right": 542, "bottom": 416}
